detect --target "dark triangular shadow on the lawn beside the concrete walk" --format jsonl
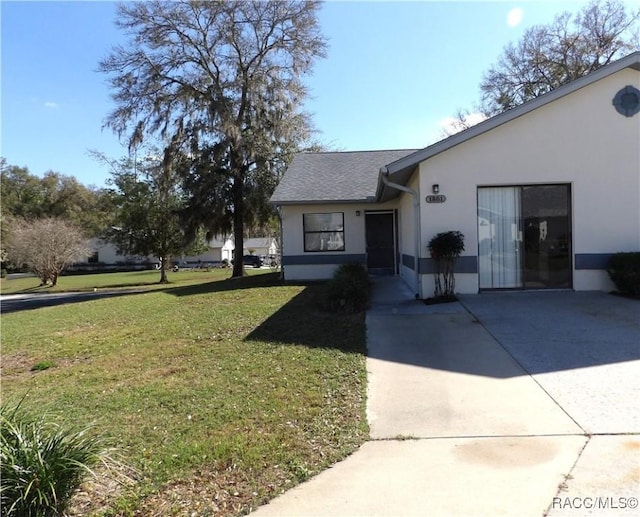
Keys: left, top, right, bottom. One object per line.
{"left": 245, "top": 284, "right": 366, "bottom": 354}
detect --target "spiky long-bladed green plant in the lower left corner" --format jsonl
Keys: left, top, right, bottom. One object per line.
{"left": 0, "top": 404, "right": 106, "bottom": 517}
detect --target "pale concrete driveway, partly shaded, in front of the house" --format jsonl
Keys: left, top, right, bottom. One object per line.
{"left": 255, "top": 278, "right": 640, "bottom": 516}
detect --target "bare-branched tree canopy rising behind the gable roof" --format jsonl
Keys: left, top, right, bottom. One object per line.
{"left": 482, "top": 0, "right": 640, "bottom": 115}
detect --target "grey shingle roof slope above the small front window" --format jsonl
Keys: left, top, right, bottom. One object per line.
{"left": 270, "top": 149, "right": 416, "bottom": 205}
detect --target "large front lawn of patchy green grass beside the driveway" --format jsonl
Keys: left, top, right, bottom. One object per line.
{"left": 2, "top": 271, "right": 367, "bottom": 515}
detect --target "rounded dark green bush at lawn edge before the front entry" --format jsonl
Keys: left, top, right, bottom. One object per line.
{"left": 327, "top": 263, "right": 370, "bottom": 312}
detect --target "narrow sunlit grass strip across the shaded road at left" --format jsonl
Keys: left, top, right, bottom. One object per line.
{"left": 0, "top": 268, "right": 267, "bottom": 294}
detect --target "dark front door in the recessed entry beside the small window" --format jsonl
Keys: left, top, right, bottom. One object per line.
{"left": 365, "top": 212, "right": 396, "bottom": 275}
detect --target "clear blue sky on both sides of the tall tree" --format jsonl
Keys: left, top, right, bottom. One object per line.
{"left": 0, "top": 0, "right": 640, "bottom": 186}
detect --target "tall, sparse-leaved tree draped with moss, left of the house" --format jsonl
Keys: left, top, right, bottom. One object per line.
{"left": 100, "top": 0, "right": 325, "bottom": 276}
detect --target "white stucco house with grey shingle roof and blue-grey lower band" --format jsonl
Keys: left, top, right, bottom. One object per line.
{"left": 271, "top": 52, "right": 640, "bottom": 298}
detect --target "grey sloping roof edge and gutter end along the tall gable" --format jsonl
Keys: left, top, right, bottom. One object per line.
{"left": 376, "top": 51, "right": 640, "bottom": 200}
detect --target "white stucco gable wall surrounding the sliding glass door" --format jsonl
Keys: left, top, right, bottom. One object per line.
{"left": 419, "top": 69, "right": 640, "bottom": 293}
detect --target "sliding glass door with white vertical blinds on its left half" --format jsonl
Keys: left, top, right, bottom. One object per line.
{"left": 478, "top": 185, "right": 571, "bottom": 289}
